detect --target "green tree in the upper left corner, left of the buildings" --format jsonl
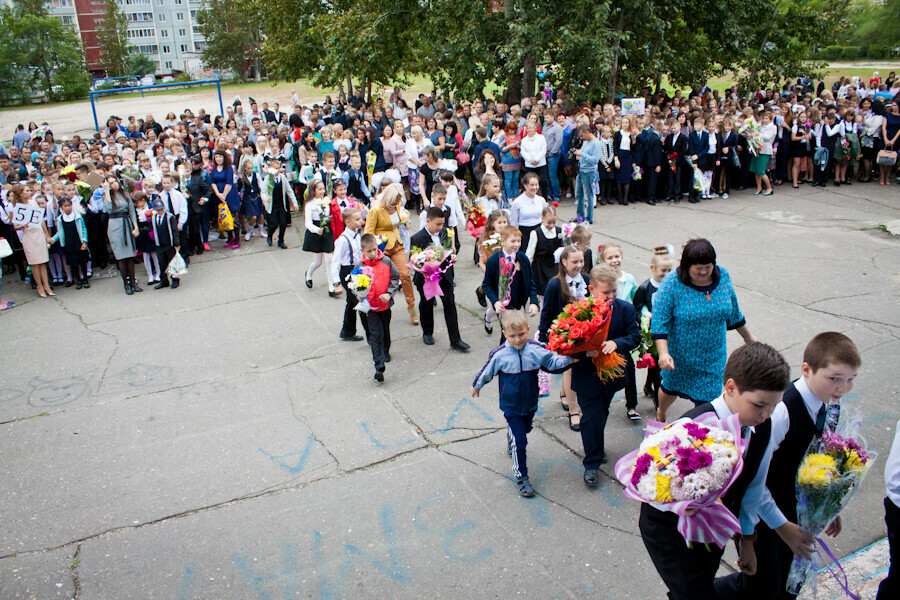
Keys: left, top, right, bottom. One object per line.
{"left": 0, "top": 0, "right": 90, "bottom": 100}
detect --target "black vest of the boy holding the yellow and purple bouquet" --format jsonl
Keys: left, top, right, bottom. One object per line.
{"left": 766, "top": 384, "right": 819, "bottom": 523}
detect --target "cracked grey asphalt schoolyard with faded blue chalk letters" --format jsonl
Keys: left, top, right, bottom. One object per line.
{"left": 0, "top": 184, "right": 900, "bottom": 600}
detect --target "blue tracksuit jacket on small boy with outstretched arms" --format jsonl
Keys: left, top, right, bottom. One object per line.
{"left": 472, "top": 340, "right": 573, "bottom": 415}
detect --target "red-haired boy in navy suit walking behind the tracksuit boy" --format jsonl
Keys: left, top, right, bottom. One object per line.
{"left": 481, "top": 227, "right": 538, "bottom": 346}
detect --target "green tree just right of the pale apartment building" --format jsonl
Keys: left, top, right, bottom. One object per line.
{"left": 197, "top": 0, "right": 264, "bottom": 81}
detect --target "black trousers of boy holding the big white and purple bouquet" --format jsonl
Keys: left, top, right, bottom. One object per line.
{"left": 640, "top": 506, "right": 723, "bottom": 600}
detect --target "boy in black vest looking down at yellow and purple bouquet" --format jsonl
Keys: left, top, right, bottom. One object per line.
{"left": 716, "top": 332, "right": 862, "bottom": 600}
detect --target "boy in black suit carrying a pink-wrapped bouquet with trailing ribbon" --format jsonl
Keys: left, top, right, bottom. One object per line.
{"left": 410, "top": 206, "right": 469, "bottom": 352}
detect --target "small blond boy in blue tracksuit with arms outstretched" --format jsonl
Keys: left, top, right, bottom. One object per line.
{"left": 472, "top": 310, "right": 573, "bottom": 498}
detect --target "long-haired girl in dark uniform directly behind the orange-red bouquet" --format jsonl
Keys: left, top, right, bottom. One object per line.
{"left": 538, "top": 245, "right": 590, "bottom": 431}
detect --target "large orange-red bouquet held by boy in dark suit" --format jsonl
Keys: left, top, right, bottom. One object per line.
{"left": 548, "top": 298, "right": 625, "bottom": 382}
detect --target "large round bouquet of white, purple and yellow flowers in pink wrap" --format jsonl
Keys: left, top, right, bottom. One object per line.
{"left": 616, "top": 412, "right": 748, "bottom": 548}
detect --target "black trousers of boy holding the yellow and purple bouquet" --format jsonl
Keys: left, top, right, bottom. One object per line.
{"left": 715, "top": 522, "right": 797, "bottom": 600}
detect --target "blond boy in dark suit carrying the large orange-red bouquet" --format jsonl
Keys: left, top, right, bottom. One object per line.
{"left": 572, "top": 265, "right": 641, "bottom": 487}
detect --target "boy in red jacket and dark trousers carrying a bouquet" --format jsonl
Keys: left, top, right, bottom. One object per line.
{"left": 359, "top": 233, "right": 400, "bottom": 383}
